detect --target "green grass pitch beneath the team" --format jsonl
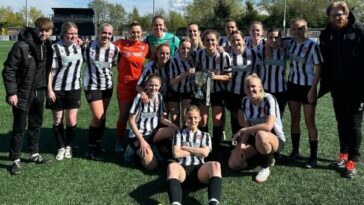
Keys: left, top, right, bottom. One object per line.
{"left": 0, "top": 39, "right": 364, "bottom": 205}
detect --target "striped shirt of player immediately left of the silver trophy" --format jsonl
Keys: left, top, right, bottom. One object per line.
{"left": 169, "top": 53, "right": 194, "bottom": 93}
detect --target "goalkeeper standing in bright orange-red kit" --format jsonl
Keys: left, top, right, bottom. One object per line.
{"left": 114, "top": 22, "right": 149, "bottom": 152}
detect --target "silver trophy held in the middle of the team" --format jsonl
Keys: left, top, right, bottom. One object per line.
{"left": 193, "top": 71, "right": 210, "bottom": 106}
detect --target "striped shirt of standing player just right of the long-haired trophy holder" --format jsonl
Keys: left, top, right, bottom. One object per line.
{"left": 227, "top": 48, "right": 258, "bottom": 94}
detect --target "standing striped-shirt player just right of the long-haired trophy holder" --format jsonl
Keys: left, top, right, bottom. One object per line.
{"left": 226, "top": 31, "right": 257, "bottom": 133}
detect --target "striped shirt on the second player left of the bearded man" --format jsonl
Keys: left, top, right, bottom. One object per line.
{"left": 259, "top": 45, "right": 288, "bottom": 93}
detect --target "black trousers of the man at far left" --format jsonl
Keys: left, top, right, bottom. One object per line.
{"left": 9, "top": 89, "right": 46, "bottom": 161}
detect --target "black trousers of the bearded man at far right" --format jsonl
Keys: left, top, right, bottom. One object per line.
{"left": 331, "top": 91, "right": 364, "bottom": 161}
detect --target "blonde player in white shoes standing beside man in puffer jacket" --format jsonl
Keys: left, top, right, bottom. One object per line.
{"left": 47, "top": 22, "right": 83, "bottom": 160}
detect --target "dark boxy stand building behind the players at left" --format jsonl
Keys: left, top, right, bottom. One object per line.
{"left": 52, "top": 8, "right": 95, "bottom": 37}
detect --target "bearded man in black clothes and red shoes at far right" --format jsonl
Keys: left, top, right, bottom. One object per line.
{"left": 319, "top": 1, "right": 364, "bottom": 178}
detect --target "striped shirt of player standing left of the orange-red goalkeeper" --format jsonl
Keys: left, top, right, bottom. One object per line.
{"left": 83, "top": 41, "right": 119, "bottom": 90}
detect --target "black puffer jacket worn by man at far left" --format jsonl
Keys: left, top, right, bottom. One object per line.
{"left": 2, "top": 28, "right": 53, "bottom": 110}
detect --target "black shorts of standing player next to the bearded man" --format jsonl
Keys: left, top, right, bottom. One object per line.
{"left": 287, "top": 82, "right": 317, "bottom": 105}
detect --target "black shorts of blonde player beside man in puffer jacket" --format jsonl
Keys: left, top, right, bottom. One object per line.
{"left": 46, "top": 89, "right": 81, "bottom": 111}
